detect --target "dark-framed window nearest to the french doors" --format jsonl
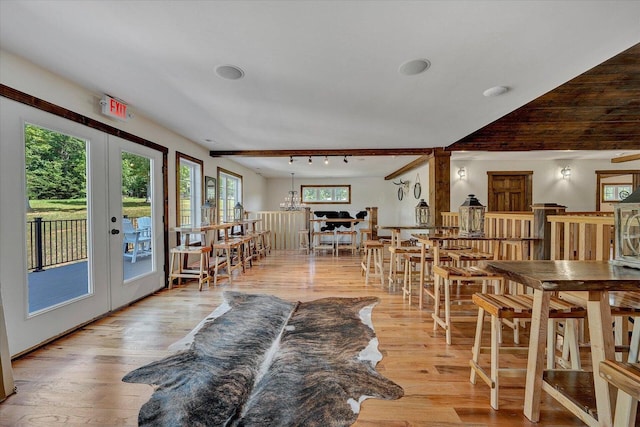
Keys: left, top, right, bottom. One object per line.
{"left": 176, "top": 153, "right": 202, "bottom": 227}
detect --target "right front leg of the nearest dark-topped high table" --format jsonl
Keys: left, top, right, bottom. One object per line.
{"left": 587, "top": 291, "right": 616, "bottom": 426}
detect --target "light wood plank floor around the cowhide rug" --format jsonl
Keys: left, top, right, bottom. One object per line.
{"left": 0, "top": 251, "right": 583, "bottom": 427}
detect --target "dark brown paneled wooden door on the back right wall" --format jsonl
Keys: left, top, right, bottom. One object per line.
{"left": 487, "top": 171, "right": 533, "bottom": 212}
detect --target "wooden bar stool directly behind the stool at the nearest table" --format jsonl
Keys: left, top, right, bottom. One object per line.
{"left": 431, "top": 266, "right": 504, "bottom": 344}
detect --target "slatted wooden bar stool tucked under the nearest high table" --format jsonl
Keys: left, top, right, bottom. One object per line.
{"left": 469, "top": 293, "right": 587, "bottom": 409}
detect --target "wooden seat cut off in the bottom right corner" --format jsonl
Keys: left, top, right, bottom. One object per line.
{"left": 599, "top": 360, "right": 640, "bottom": 427}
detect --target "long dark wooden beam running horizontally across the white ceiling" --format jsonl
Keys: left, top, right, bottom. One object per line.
{"left": 209, "top": 148, "right": 433, "bottom": 157}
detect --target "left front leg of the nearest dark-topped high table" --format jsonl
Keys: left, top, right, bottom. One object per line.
{"left": 524, "top": 289, "right": 551, "bottom": 423}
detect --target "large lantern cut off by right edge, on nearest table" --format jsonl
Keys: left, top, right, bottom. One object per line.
{"left": 611, "top": 187, "right": 640, "bottom": 268}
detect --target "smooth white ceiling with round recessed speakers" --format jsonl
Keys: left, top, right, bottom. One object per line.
{"left": 0, "top": 0, "right": 640, "bottom": 177}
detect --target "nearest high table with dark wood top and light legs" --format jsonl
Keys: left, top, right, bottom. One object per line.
{"left": 485, "top": 261, "right": 640, "bottom": 426}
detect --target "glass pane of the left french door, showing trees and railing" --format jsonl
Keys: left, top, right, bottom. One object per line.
{"left": 24, "top": 123, "right": 91, "bottom": 315}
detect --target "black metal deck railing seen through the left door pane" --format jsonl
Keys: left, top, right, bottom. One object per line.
{"left": 27, "top": 218, "right": 87, "bottom": 271}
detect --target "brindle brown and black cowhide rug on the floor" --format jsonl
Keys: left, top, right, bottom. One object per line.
{"left": 123, "top": 292, "right": 403, "bottom": 426}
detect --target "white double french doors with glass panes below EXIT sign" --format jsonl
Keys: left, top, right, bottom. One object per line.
{"left": 0, "top": 98, "right": 164, "bottom": 355}
